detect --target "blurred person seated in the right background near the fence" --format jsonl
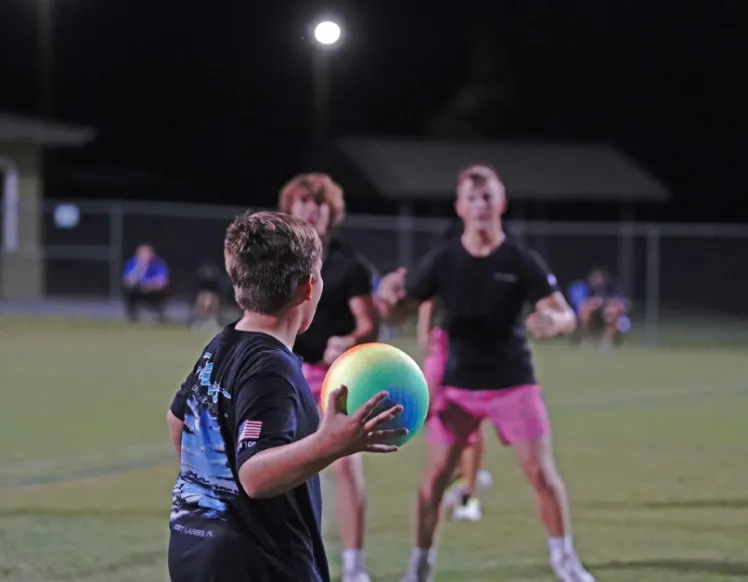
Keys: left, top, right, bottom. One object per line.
{"left": 569, "top": 267, "right": 628, "bottom": 347}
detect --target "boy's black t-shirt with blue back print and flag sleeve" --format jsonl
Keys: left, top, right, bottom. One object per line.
{"left": 170, "top": 324, "right": 330, "bottom": 582}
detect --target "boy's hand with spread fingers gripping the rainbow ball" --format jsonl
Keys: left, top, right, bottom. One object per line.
{"left": 319, "top": 386, "right": 408, "bottom": 457}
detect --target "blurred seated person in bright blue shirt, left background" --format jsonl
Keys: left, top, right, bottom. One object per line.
{"left": 122, "top": 244, "right": 169, "bottom": 323}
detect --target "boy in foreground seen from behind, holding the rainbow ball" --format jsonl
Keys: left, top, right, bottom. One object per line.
{"left": 167, "top": 212, "right": 404, "bottom": 582}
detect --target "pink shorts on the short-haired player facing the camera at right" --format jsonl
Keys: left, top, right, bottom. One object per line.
{"left": 427, "top": 384, "right": 551, "bottom": 445}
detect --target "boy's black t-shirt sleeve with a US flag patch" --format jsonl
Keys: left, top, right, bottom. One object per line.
{"left": 233, "top": 374, "right": 299, "bottom": 470}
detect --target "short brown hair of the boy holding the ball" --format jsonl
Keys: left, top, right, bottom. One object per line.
{"left": 223, "top": 211, "right": 322, "bottom": 315}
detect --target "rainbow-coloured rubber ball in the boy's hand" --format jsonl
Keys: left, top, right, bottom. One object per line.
{"left": 320, "top": 343, "right": 429, "bottom": 446}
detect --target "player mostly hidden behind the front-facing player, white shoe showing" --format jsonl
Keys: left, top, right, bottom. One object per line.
{"left": 416, "top": 222, "right": 493, "bottom": 521}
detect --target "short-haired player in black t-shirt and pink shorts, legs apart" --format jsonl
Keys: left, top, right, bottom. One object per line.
{"left": 379, "top": 166, "right": 594, "bottom": 582}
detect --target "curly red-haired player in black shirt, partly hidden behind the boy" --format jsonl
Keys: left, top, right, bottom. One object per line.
{"left": 278, "top": 173, "right": 379, "bottom": 582}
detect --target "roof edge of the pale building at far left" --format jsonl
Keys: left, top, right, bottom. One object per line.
{"left": 0, "top": 112, "right": 96, "bottom": 147}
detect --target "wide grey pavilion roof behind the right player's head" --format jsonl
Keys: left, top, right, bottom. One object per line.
{"left": 338, "top": 138, "right": 669, "bottom": 202}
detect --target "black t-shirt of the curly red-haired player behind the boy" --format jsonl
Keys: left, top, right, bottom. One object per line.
{"left": 294, "top": 240, "right": 373, "bottom": 364}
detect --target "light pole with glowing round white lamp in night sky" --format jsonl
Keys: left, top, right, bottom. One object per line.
{"left": 313, "top": 18, "right": 343, "bottom": 147}
